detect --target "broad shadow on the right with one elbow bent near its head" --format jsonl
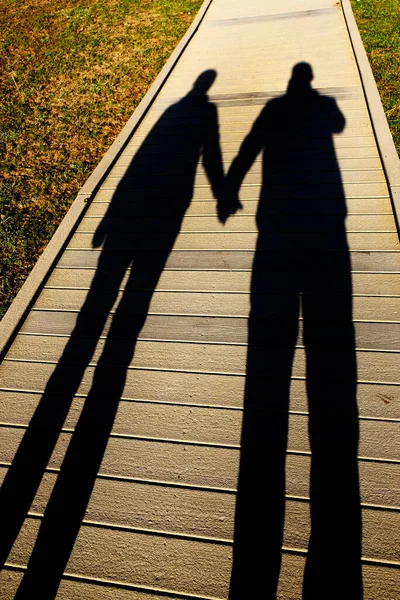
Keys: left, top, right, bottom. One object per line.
{"left": 223, "top": 63, "right": 362, "bottom": 600}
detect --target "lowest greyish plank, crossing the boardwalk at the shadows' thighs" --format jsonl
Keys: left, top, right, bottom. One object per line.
{"left": 21, "top": 310, "right": 400, "bottom": 353}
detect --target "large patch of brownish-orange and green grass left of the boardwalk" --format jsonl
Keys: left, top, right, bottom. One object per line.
{"left": 0, "top": 0, "right": 202, "bottom": 318}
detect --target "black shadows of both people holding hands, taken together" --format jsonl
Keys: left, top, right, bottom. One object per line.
{"left": 0, "top": 63, "right": 362, "bottom": 600}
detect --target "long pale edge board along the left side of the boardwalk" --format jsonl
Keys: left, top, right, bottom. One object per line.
{"left": 0, "top": 0, "right": 213, "bottom": 362}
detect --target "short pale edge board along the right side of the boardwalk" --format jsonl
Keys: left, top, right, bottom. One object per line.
{"left": 341, "top": 0, "right": 400, "bottom": 233}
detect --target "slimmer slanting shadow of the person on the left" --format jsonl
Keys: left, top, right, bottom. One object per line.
{"left": 0, "top": 70, "right": 224, "bottom": 600}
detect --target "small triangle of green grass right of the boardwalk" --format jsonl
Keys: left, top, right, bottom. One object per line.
{"left": 351, "top": 0, "right": 400, "bottom": 155}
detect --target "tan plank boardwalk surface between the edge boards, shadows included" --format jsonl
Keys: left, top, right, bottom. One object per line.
{"left": 0, "top": 0, "right": 400, "bottom": 600}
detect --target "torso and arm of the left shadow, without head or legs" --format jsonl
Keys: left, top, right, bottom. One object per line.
{"left": 94, "top": 92, "right": 222, "bottom": 258}
